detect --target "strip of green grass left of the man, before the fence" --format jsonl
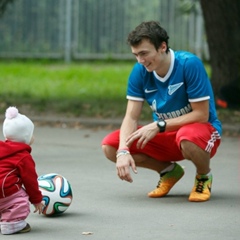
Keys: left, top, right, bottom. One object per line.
{"left": 0, "top": 62, "right": 152, "bottom": 118}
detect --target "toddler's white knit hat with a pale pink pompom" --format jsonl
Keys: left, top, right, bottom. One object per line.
{"left": 3, "top": 107, "right": 34, "bottom": 144}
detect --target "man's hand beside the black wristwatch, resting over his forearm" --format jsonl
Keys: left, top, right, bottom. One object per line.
{"left": 126, "top": 122, "right": 159, "bottom": 149}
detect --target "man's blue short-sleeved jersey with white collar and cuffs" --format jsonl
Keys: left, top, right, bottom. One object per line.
{"left": 127, "top": 49, "right": 222, "bottom": 135}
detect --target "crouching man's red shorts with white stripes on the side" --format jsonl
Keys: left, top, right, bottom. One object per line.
{"left": 102, "top": 123, "right": 221, "bottom": 161}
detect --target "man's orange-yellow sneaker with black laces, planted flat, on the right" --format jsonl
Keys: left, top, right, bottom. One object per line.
{"left": 188, "top": 175, "right": 212, "bottom": 202}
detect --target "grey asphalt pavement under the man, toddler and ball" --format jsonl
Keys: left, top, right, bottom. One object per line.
{"left": 0, "top": 124, "right": 240, "bottom": 240}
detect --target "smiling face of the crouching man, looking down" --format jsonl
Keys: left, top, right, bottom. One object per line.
{"left": 131, "top": 39, "right": 162, "bottom": 72}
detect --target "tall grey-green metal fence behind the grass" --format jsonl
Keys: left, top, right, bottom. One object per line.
{"left": 0, "top": 0, "right": 207, "bottom": 62}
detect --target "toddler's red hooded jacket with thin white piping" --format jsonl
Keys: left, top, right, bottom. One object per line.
{"left": 0, "top": 141, "right": 42, "bottom": 204}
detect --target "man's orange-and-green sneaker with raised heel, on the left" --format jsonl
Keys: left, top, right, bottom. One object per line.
{"left": 148, "top": 163, "right": 184, "bottom": 198}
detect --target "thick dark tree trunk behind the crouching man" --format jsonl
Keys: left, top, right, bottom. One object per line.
{"left": 200, "top": 0, "right": 240, "bottom": 95}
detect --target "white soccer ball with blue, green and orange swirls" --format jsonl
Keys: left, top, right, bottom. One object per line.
{"left": 38, "top": 173, "right": 73, "bottom": 216}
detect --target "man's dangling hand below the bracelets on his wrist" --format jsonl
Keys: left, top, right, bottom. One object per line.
{"left": 116, "top": 154, "right": 137, "bottom": 182}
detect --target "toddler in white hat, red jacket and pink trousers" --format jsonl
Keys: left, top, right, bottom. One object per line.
{"left": 0, "top": 107, "right": 44, "bottom": 235}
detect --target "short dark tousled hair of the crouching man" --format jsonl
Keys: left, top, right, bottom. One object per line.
{"left": 127, "top": 21, "right": 169, "bottom": 52}
